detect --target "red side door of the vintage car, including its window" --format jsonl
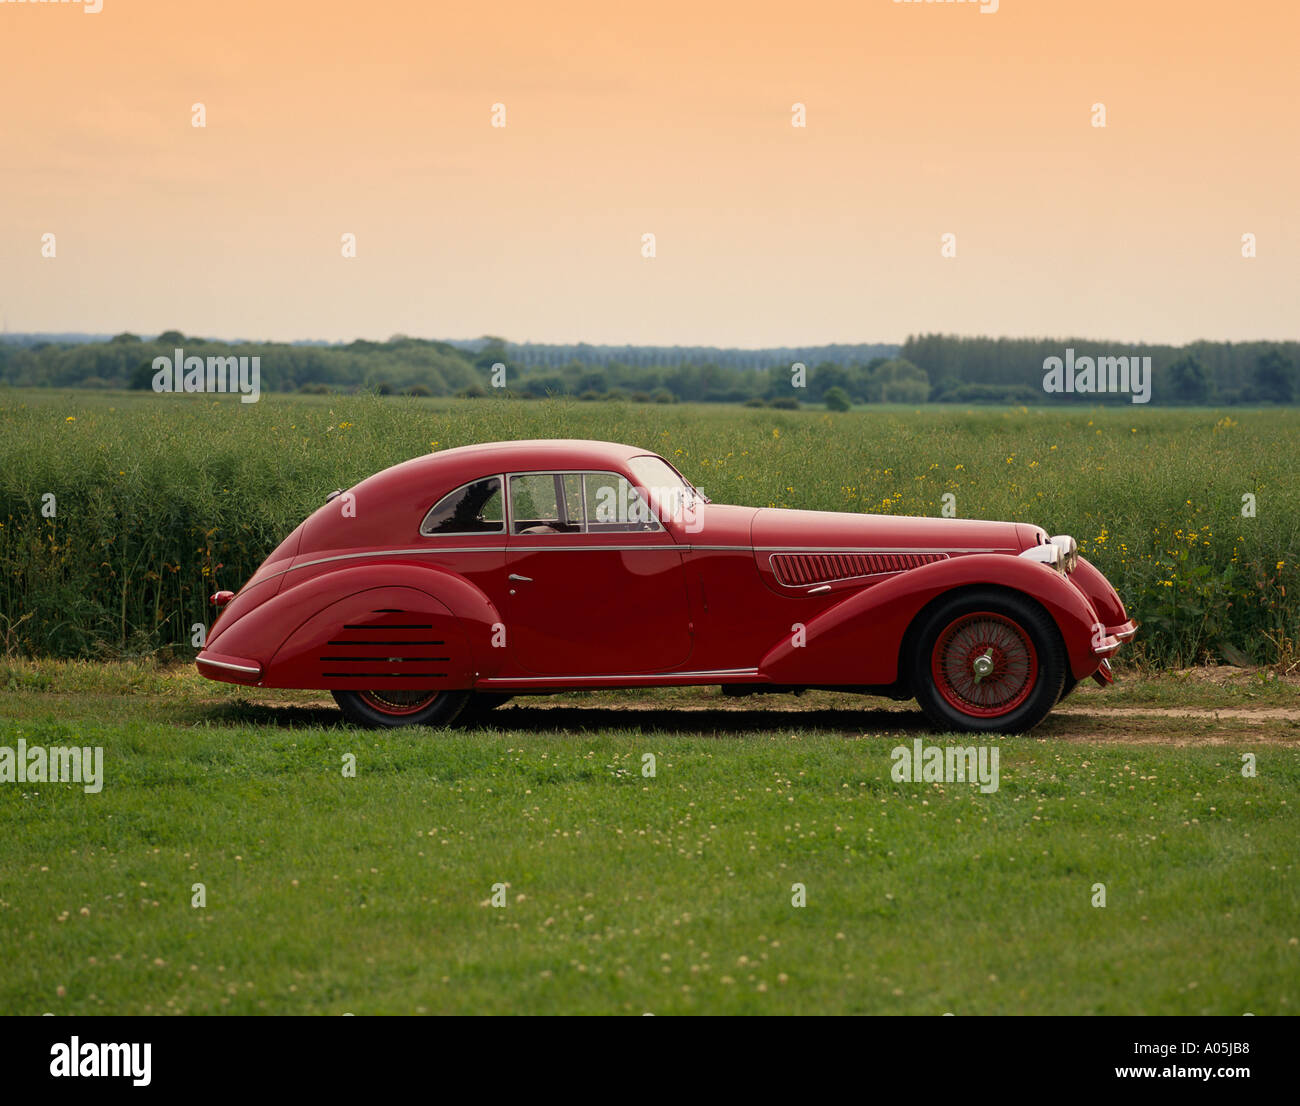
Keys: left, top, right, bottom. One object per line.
{"left": 506, "top": 472, "right": 692, "bottom": 676}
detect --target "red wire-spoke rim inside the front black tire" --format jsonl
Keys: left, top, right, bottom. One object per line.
{"left": 931, "top": 611, "right": 1039, "bottom": 719}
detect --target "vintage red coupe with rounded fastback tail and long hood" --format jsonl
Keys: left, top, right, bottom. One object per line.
{"left": 198, "top": 441, "right": 1135, "bottom": 732}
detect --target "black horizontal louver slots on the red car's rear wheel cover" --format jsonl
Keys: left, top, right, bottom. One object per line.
{"left": 319, "top": 608, "right": 451, "bottom": 680}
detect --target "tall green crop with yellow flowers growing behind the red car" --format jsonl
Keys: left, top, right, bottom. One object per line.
{"left": 0, "top": 390, "right": 1300, "bottom": 664}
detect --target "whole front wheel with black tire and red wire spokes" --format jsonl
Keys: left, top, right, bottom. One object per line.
{"left": 911, "top": 589, "right": 1067, "bottom": 733}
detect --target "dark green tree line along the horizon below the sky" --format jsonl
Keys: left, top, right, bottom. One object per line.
{"left": 0, "top": 330, "right": 1300, "bottom": 409}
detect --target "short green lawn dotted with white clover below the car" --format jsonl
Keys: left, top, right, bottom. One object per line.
{"left": 0, "top": 665, "right": 1300, "bottom": 1015}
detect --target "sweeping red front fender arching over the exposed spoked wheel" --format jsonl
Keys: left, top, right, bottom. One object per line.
{"left": 759, "top": 554, "right": 1101, "bottom": 686}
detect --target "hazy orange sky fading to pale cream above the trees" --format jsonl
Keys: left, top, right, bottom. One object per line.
{"left": 0, "top": 0, "right": 1300, "bottom": 346}
